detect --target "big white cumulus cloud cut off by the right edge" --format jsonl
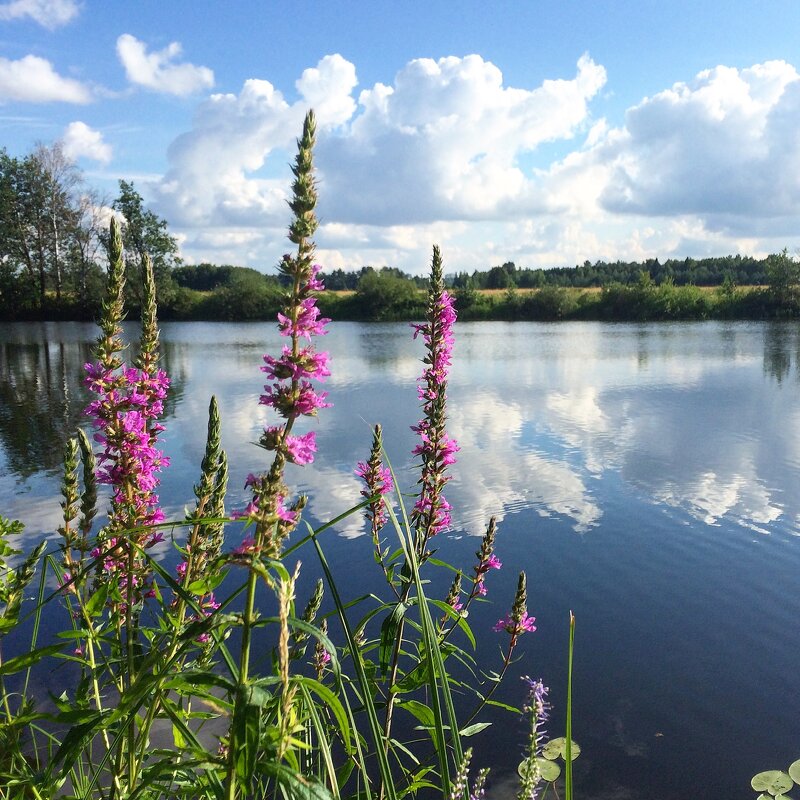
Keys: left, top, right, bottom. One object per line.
{"left": 599, "top": 61, "right": 800, "bottom": 229}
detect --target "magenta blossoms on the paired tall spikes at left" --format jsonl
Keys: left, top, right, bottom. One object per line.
{"left": 84, "top": 363, "right": 169, "bottom": 532}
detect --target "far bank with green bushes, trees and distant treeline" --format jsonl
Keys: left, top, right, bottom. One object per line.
{"left": 0, "top": 144, "right": 800, "bottom": 321}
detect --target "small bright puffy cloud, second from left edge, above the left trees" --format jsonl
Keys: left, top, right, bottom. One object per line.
{"left": 117, "top": 33, "right": 214, "bottom": 96}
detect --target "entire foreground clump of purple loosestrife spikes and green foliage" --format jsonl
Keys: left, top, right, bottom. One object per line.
{"left": 0, "top": 114, "right": 576, "bottom": 800}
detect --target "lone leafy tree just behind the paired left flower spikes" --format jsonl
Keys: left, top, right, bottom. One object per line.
{"left": 114, "top": 180, "right": 181, "bottom": 304}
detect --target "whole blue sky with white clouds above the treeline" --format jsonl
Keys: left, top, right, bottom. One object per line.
{"left": 0, "top": 0, "right": 800, "bottom": 273}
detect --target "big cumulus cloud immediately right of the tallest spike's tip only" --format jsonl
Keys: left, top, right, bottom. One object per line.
{"left": 319, "top": 50, "right": 606, "bottom": 224}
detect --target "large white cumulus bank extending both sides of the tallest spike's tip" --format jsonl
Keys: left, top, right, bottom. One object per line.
{"left": 159, "top": 55, "right": 605, "bottom": 239}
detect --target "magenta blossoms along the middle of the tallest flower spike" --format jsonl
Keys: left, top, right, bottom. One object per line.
{"left": 259, "top": 264, "right": 331, "bottom": 465}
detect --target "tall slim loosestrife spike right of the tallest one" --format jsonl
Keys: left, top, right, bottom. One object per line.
{"left": 411, "top": 246, "right": 459, "bottom": 559}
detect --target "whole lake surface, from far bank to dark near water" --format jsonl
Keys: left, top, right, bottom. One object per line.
{"left": 0, "top": 323, "right": 800, "bottom": 800}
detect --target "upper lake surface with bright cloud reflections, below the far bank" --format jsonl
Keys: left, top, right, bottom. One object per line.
{"left": 0, "top": 323, "right": 800, "bottom": 537}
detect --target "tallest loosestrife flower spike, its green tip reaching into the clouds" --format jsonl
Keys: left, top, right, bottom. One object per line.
{"left": 233, "top": 111, "right": 330, "bottom": 558}
